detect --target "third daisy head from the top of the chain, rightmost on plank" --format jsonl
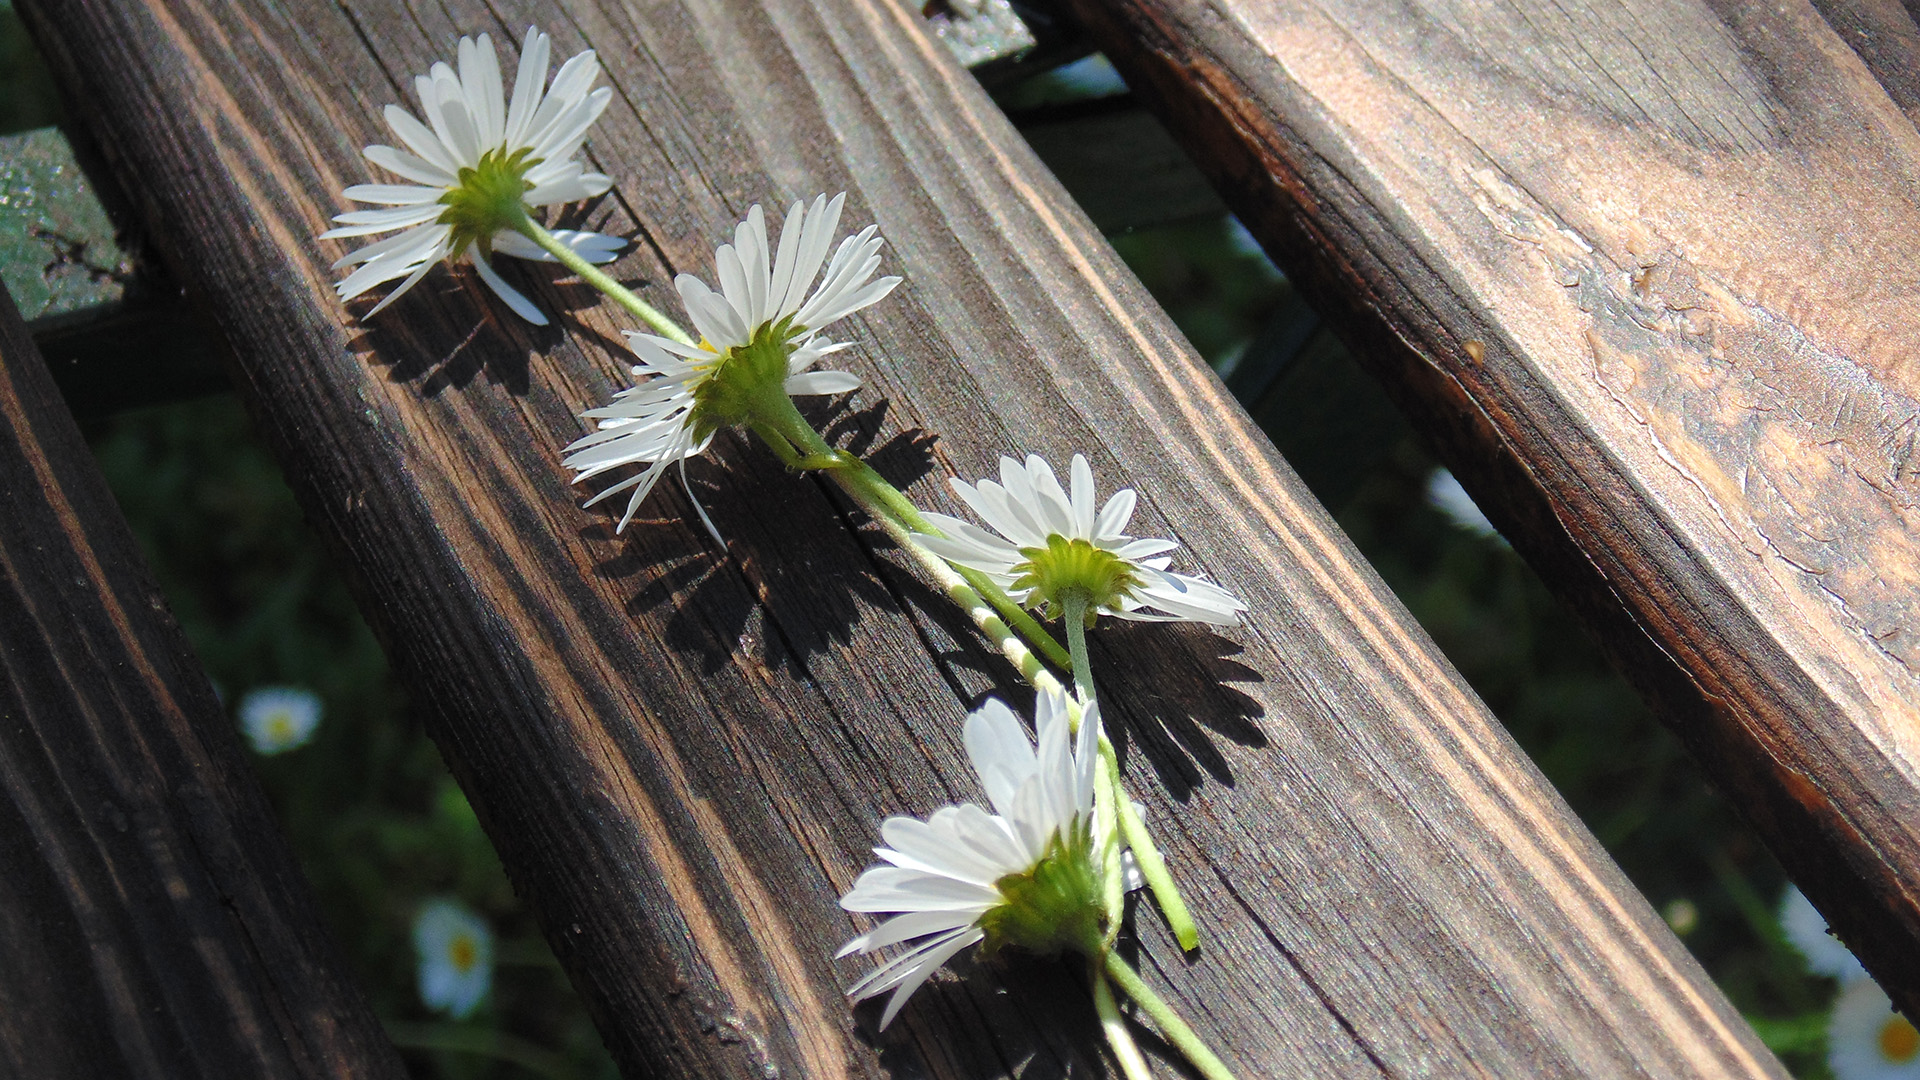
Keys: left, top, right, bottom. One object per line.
{"left": 920, "top": 454, "right": 1246, "bottom": 626}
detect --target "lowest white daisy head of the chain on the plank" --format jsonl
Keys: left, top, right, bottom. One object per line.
{"left": 839, "top": 694, "right": 1140, "bottom": 1028}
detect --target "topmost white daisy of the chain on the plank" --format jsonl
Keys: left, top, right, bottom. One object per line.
{"left": 321, "top": 27, "right": 622, "bottom": 327}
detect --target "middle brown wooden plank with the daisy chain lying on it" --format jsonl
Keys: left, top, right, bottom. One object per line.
{"left": 23, "top": 0, "right": 1780, "bottom": 1078}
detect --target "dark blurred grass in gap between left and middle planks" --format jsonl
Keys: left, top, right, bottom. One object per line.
{"left": 88, "top": 396, "right": 614, "bottom": 1080}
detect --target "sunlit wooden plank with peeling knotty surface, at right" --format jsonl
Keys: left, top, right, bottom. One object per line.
{"left": 1052, "top": 0, "right": 1920, "bottom": 1011}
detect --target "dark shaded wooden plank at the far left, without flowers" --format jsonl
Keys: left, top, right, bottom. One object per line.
{"left": 0, "top": 282, "right": 405, "bottom": 1080}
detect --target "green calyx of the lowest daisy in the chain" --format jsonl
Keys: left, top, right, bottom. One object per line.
{"left": 979, "top": 822, "right": 1106, "bottom": 957}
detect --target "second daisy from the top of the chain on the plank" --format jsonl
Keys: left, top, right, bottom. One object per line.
{"left": 564, "top": 194, "right": 900, "bottom": 528}
